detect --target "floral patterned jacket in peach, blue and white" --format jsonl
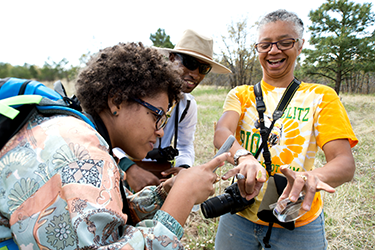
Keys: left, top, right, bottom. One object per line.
{"left": 0, "top": 115, "right": 183, "bottom": 250}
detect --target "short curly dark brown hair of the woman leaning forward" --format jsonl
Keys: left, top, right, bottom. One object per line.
{"left": 75, "top": 43, "right": 182, "bottom": 115}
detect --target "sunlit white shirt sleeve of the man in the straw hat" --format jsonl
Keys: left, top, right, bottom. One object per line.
{"left": 175, "top": 99, "right": 198, "bottom": 167}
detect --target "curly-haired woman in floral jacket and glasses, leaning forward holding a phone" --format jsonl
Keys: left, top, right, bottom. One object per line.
{"left": 0, "top": 43, "right": 228, "bottom": 249}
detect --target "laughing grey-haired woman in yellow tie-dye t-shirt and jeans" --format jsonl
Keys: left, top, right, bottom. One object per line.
{"left": 214, "top": 10, "right": 358, "bottom": 250}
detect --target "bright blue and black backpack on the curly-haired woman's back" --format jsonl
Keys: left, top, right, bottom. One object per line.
{"left": 0, "top": 78, "right": 95, "bottom": 149}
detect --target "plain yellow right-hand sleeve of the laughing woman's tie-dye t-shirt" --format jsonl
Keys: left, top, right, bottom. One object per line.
{"left": 314, "top": 85, "right": 358, "bottom": 147}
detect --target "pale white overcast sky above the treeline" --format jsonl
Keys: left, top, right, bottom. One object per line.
{"left": 0, "top": 0, "right": 374, "bottom": 67}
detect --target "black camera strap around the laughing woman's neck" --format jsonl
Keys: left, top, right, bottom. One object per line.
{"left": 254, "top": 78, "right": 301, "bottom": 248}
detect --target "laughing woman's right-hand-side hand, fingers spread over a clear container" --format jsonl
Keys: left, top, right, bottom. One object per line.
{"left": 279, "top": 166, "right": 335, "bottom": 211}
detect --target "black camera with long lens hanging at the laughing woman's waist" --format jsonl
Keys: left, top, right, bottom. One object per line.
{"left": 201, "top": 182, "right": 254, "bottom": 219}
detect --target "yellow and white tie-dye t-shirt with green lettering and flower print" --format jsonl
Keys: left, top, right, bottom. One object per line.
{"left": 224, "top": 80, "right": 358, "bottom": 227}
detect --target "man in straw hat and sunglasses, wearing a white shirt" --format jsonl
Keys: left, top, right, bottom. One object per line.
{"left": 114, "top": 29, "right": 231, "bottom": 191}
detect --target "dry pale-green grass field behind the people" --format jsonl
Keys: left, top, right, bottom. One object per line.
{"left": 183, "top": 86, "right": 375, "bottom": 250}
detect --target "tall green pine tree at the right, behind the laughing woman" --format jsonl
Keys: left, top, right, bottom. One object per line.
{"left": 303, "top": 0, "right": 375, "bottom": 93}
